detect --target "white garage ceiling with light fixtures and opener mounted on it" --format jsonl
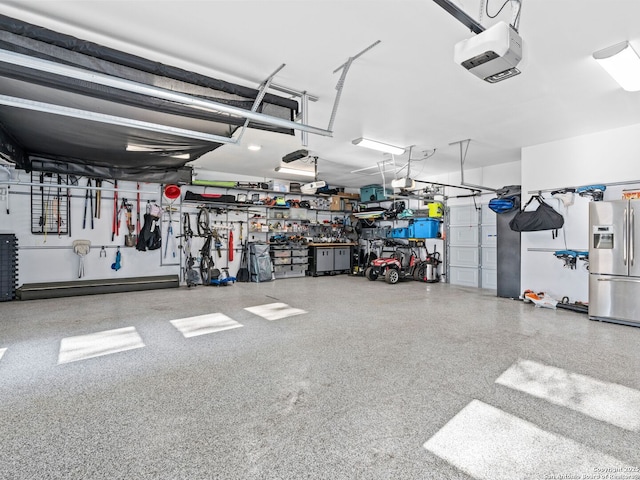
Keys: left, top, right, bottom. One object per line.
{"left": 0, "top": 0, "right": 640, "bottom": 187}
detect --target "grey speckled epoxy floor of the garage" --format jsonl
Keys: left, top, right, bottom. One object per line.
{"left": 0, "top": 275, "right": 640, "bottom": 480}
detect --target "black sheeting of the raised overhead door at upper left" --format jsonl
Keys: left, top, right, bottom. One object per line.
{"left": 0, "top": 15, "right": 298, "bottom": 183}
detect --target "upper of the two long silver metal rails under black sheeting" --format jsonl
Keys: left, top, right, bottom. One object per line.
{"left": 0, "top": 49, "right": 333, "bottom": 139}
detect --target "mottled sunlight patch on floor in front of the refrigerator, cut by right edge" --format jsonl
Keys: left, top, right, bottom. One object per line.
{"left": 496, "top": 360, "right": 640, "bottom": 431}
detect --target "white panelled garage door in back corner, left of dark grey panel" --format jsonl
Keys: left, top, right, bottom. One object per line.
{"left": 447, "top": 205, "right": 497, "bottom": 289}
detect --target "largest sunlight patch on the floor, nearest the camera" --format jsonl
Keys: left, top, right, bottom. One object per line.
{"left": 424, "top": 400, "right": 633, "bottom": 480}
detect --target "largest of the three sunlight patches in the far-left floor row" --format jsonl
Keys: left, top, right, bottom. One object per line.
{"left": 58, "top": 327, "right": 144, "bottom": 365}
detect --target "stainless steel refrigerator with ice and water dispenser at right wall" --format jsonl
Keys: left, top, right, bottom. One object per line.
{"left": 589, "top": 200, "right": 640, "bottom": 326}
